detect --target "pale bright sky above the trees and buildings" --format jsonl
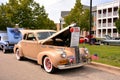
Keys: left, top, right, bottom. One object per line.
{"left": 0, "top": 0, "right": 114, "bottom": 23}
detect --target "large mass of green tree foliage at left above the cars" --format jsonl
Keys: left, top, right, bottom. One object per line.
{"left": 0, "top": 0, "right": 55, "bottom": 30}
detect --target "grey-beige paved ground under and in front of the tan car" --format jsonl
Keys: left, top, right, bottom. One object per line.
{"left": 0, "top": 51, "right": 120, "bottom": 80}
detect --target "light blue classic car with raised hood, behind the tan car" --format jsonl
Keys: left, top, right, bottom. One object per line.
{"left": 0, "top": 27, "right": 22, "bottom": 53}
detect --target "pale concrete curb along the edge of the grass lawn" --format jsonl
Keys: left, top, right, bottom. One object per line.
{"left": 90, "top": 62, "right": 120, "bottom": 75}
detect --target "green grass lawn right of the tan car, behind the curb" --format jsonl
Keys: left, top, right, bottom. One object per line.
{"left": 80, "top": 44, "right": 120, "bottom": 67}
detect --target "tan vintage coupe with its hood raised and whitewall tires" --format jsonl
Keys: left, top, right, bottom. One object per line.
{"left": 14, "top": 26, "right": 90, "bottom": 73}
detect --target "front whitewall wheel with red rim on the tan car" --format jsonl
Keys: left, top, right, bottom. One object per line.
{"left": 43, "top": 57, "right": 55, "bottom": 73}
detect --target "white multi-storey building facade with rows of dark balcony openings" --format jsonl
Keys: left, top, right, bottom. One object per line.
{"left": 96, "top": 0, "right": 120, "bottom": 38}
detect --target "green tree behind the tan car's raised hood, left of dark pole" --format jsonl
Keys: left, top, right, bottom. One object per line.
{"left": 64, "top": 0, "right": 90, "bottom": 31}
